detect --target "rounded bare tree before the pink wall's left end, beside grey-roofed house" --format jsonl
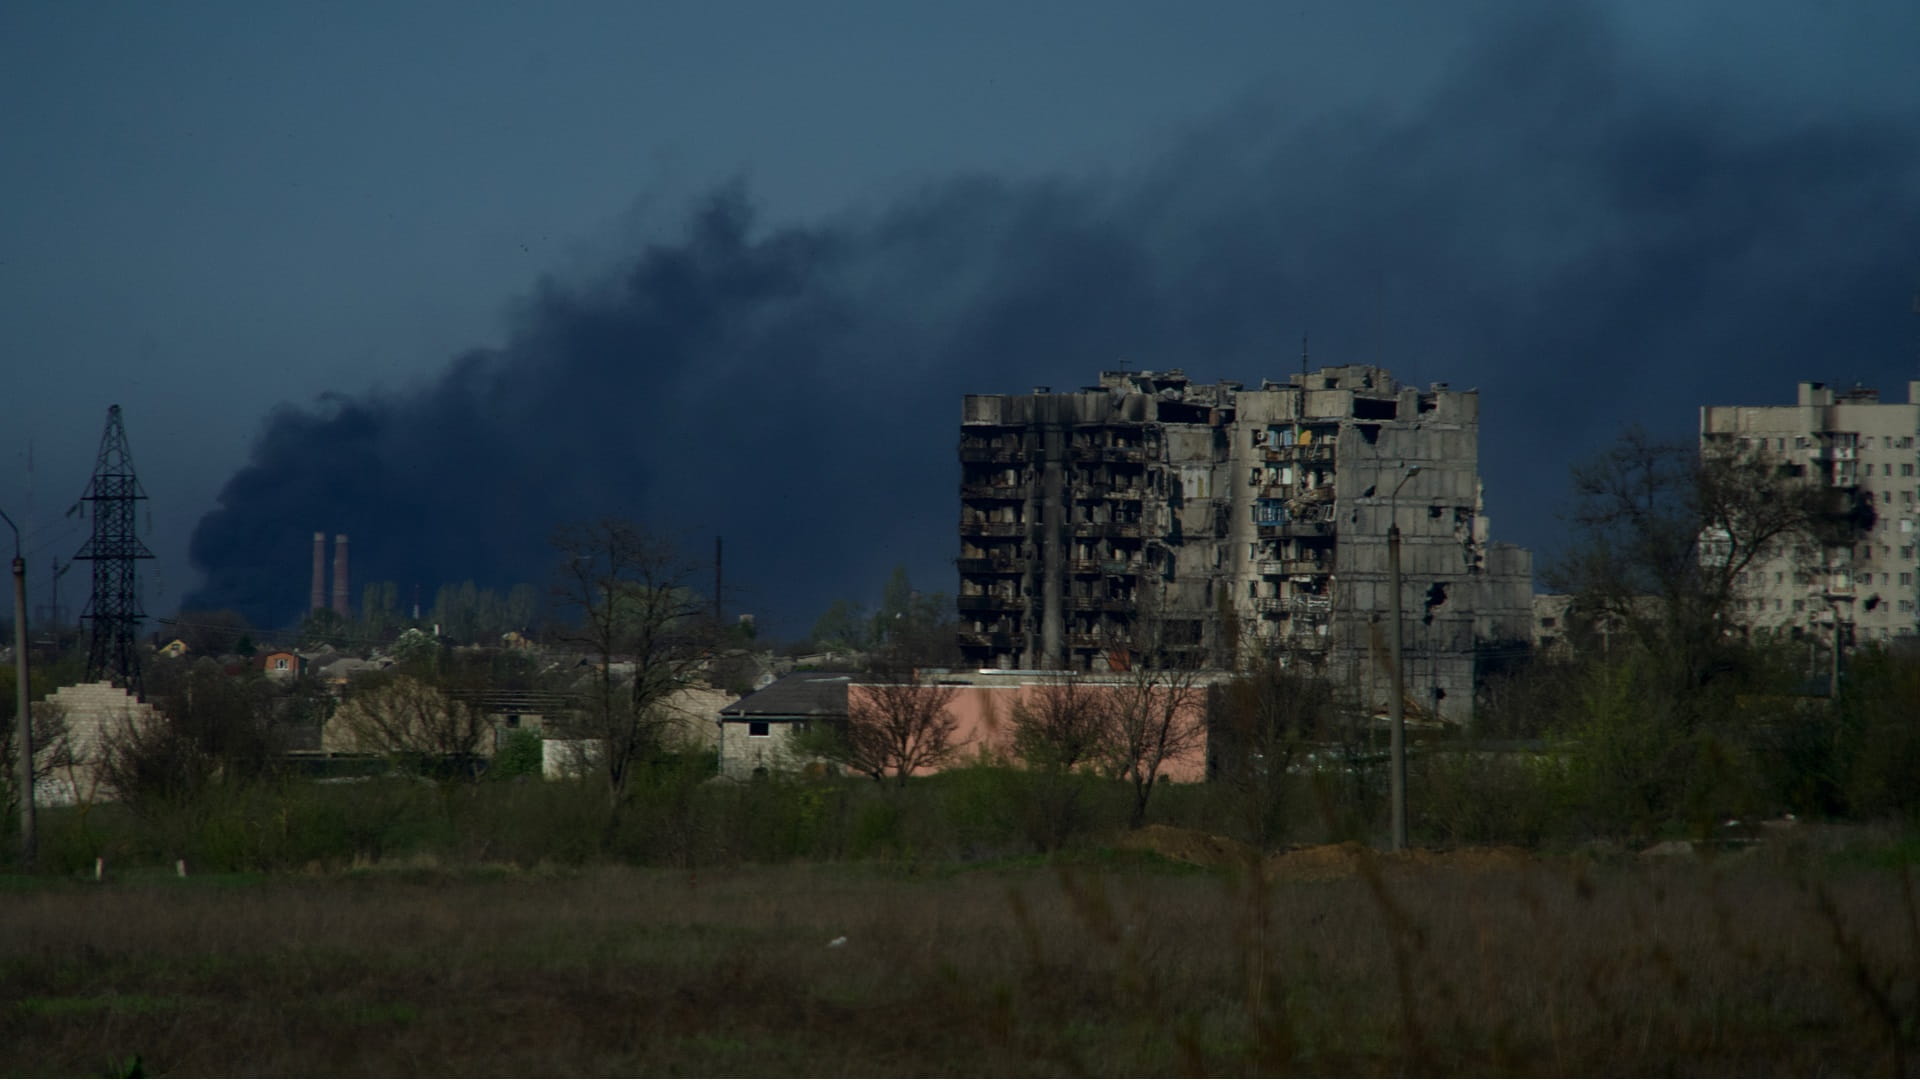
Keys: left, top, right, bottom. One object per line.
{"left": 837, "top": 651, "right": 960, "bottom": 786}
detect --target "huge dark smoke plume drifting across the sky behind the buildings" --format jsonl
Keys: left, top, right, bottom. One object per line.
{"left": 186, "top": 10, "right": 1920, "bottom": 634}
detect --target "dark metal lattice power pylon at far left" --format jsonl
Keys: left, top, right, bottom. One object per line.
{"left": 73, "top": 405, "right": 154, "bottom": 692}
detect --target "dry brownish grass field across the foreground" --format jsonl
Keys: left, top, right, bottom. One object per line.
{"left": 0, "top": 844, "right": 1920, "bottom": 1074}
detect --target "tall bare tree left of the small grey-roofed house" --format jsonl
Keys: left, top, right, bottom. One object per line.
{"left": 553, "top": 519, "right": 712, "bottom": 807}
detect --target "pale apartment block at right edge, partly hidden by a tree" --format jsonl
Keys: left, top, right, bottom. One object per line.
{"left": 1699, "top": 380, "right": 1920, "bottom": 644}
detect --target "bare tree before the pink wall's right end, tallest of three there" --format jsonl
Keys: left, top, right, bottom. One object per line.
{"left": 1102, "top": 613, "right": 1206, "bottom": 828}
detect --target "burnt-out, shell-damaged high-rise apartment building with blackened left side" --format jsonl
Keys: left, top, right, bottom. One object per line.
{"left": 958, "top": 365, "right": 1532, "bottom": 721}
